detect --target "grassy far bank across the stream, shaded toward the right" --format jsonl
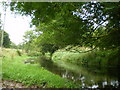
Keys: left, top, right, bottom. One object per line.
{"left": 52, "top": 47, "right": 120, "bottom": 67}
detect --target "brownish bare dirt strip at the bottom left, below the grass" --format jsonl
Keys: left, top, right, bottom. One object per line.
{"left": 0, "top": 80, "right": 38, "bottom": 88}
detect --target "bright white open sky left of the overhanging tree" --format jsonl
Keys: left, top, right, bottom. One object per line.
{"left": 0, "top": 4, "right": 33, "bottom": 45}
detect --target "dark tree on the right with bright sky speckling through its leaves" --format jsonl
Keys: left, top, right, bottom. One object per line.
{"left": 74, "top": 2, "right": 120, "bottom": 49}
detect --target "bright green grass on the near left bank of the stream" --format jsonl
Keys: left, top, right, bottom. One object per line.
{"left": 2, "top": 50, "right": 79, "bottom": 88}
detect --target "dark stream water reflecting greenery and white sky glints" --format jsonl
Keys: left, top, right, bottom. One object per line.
{"left": 41, "top": 61, "right": 120, "bottom": 89}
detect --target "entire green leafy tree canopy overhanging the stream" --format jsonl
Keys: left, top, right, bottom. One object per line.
{"left": 10, "top": 2, "right": 120, "bottom": 49}
